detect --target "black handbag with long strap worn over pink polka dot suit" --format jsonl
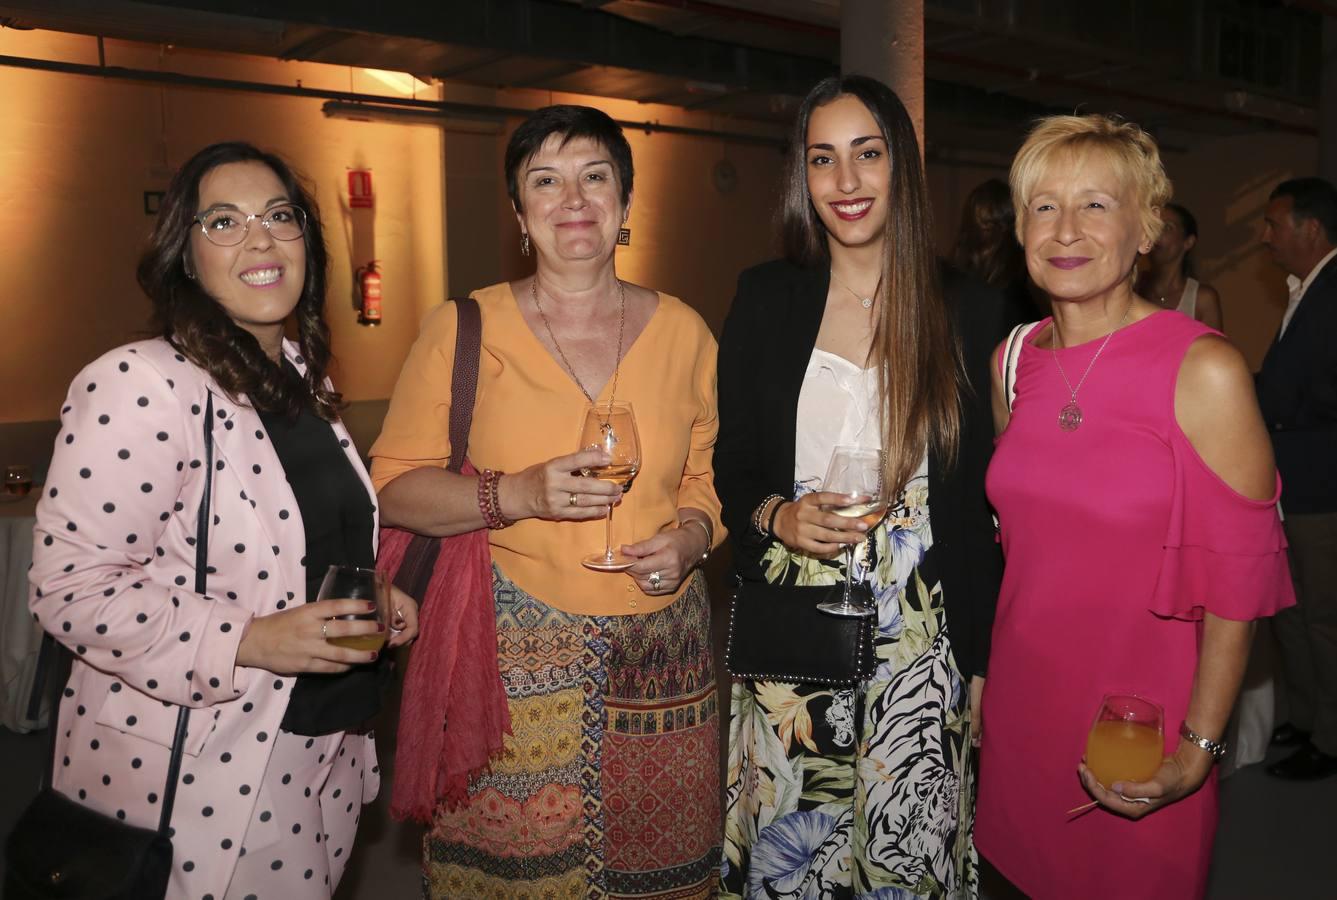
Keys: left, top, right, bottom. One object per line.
{"left": 4, "top": 395, "right": 214, "bottom": 900}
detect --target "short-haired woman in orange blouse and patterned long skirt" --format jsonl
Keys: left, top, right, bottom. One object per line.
{"left": 372, "top": 106, "right": 723, "bottom": 897}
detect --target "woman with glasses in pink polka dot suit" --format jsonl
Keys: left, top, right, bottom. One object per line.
{"left": 29, "top": 143, "right": 417, "bottom": 900}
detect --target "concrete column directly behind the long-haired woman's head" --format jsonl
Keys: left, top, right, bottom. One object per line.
{"left": 840, "top": 0, "right": 924, "bottom": 150}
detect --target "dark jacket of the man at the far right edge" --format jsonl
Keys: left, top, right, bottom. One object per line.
{"left": 1257, "top": 258, "right": 1337, "bottom": 514}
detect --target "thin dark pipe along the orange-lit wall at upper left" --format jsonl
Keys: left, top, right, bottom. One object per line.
{"left": 0, "top": 56, "right": 785, "bottom": 148}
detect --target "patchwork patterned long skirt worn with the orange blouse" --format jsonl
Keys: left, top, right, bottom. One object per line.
{"left": 422, "top": 568, "right": 721, "bottom": 900}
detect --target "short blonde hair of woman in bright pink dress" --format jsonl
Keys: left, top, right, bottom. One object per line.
{"left": 1008, "top": 112, "right": 1173, "bottom": 251}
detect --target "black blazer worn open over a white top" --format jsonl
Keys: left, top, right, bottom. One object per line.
{"left": 715, "top": 261, "right": 1007, "bottom": 677}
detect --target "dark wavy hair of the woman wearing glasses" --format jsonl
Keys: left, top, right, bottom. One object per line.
{"left": 136, "top": 142, "right": 344, "bottom": 421}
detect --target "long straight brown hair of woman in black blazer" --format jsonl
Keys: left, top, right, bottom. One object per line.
{"left": 781, "top": 75, "right": 965, "bottom": 496}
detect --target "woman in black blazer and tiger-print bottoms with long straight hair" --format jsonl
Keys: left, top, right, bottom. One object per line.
{"left": 715, "top": 76, "right": 1000, "bottom": 899}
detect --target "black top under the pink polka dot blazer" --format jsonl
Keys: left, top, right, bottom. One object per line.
{"left": 259, "top": 385, "right": 388, "bottom": 736}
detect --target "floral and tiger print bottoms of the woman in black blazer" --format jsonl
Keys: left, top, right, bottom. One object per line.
{"left": 721, "top": 471, "right": 979, "bottom": 900}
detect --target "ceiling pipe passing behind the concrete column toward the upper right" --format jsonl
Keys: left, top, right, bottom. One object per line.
{"left": 630, "top": 0, "right": 1320, "bottom": 138}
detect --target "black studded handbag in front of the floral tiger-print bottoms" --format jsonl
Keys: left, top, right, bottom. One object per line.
{"left": 725, "top": 580, "right": 877, "bottom": 687}
